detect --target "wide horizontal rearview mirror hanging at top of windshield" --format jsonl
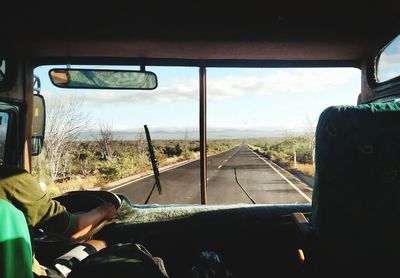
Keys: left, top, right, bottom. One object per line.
{"left": 49, "top": 69, "right": 157, "bottom": 90}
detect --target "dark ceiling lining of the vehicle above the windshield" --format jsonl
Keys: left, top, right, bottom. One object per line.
{"left": 2, "top": 0, "right": 400, "bottom": 62}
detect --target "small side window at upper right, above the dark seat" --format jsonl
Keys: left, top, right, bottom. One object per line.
{"left": 376, "top": 35, "right": 400, "bottom": 83}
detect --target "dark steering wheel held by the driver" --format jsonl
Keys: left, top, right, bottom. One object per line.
{"left": 33, "top": 191, "right": 122, "bottom": 245}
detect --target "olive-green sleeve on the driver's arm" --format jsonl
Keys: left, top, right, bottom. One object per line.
{"left": 0, "top": 167, "right": 78, "bottom": 236}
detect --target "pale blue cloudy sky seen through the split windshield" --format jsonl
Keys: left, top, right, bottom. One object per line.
{"left": 35, "top": 66, "right": 361, "bottom": 138}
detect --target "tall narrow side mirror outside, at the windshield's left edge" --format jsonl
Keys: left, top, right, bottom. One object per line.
{"left": 32, "top": 95, "right": 46, "bottom": 156}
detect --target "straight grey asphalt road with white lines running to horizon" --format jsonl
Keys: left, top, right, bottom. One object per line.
{"left": 111, "top": 144, "right": 312, "bottom": 204}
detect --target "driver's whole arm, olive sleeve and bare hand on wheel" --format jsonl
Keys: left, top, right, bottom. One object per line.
{"left": 0, "top": 166, "right": 117, "bottom": 238}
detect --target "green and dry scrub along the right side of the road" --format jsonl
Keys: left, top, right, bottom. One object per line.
{"left": 249, "top": 134, "right": 315, "bottom": 181}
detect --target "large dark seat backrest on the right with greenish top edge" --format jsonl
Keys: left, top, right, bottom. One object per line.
{"left": 312, "top": 102, "right": 400, "bottom": 263}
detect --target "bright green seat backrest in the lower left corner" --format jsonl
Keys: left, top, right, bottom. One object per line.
{"left": 0, "top": 199, "right": 33, "bottom": 278}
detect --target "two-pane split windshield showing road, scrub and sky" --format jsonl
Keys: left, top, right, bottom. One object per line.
{"left": 33, "top": 65, "right": 361, "bottom": 204}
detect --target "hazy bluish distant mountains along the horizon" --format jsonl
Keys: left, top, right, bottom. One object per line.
{"left": 79, "top": 127, "right": 304, "bottom": 140}
